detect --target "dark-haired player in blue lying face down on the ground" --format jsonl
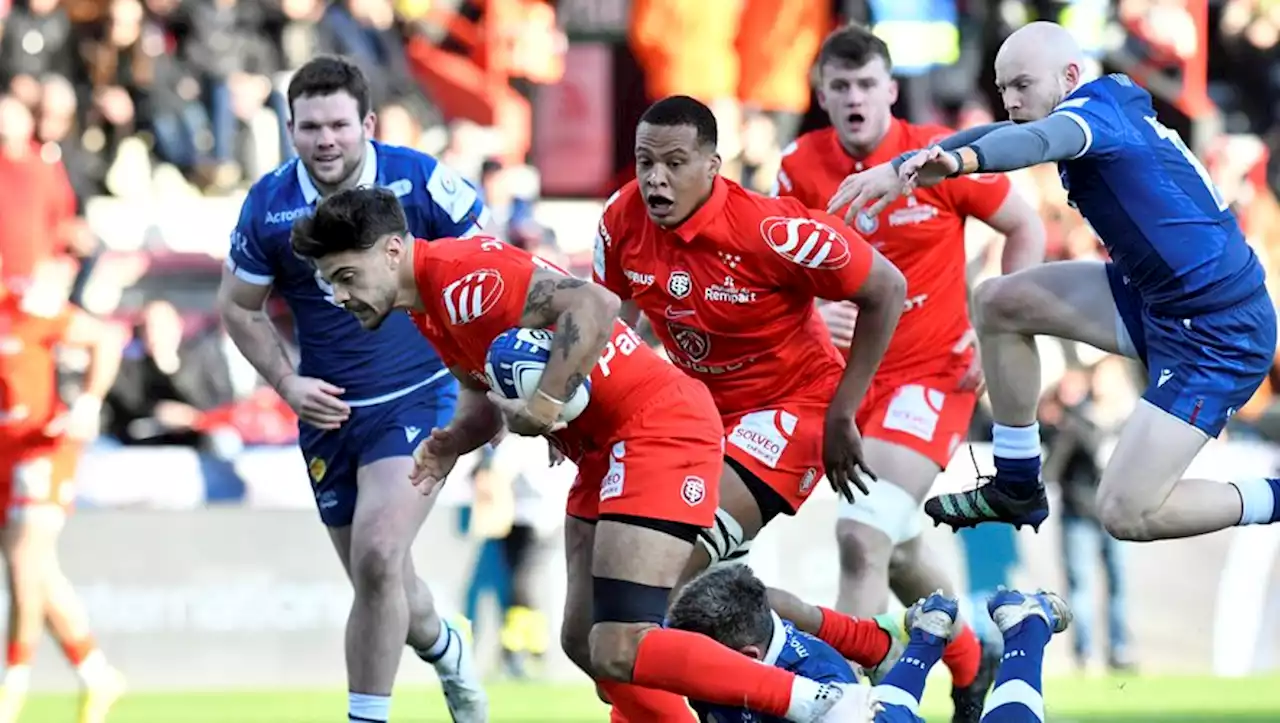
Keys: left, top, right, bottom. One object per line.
{"left": 667, "top": 564, "right": 1071, "bottom": 723}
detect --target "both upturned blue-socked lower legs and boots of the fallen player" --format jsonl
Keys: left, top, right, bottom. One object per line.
{"left": 873, "top": 590, "right": 1071, "bottom": 723}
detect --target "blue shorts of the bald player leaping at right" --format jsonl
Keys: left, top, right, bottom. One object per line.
{"left": 1107, "top": 264, "right": 1276, "bottom": 436}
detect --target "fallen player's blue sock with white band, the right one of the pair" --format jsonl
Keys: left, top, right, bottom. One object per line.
{"left": 982, "top": 616, "right": 1053, "bottom": 723}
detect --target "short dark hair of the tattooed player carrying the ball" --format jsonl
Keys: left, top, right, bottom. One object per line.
{"left": 289, "top": 188, "right": 408, "bottom": 258}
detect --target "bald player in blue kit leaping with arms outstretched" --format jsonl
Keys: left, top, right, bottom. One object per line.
{"left": 831, "top": 22, "right": 1280, "bottom": 541}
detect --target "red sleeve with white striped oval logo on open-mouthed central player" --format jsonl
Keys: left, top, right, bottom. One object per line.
{"left": 760, "top": 200, "right": 874, "bottom": 301}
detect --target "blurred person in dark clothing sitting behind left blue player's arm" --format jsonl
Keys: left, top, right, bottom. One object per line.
{"left": 105, "top": 295, "right": 233, "bottom": 447}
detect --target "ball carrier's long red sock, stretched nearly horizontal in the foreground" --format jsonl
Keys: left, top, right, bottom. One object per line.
{"left": 631, "top": 628, "right": 796, "bottom": 715}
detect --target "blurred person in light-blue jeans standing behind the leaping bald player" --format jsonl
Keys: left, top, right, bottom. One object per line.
{"left": 1039, "top": 357, "right": 1133, "bottom": 671}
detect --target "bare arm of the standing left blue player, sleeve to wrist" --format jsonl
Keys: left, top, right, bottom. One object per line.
{"left": 218, "top": 267, "right": 294, "bottom": 390}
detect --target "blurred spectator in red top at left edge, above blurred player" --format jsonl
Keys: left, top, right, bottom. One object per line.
{"left": 0, "top": 95, "right": 83, "bottom": 293}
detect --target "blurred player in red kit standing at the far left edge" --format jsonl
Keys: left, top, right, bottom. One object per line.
{"left": 0, "top": 261, "right": 124, "bottom": 723}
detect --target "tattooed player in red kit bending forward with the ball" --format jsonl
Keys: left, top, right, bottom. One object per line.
{"left": 293, "top": 188, "right": 858, "bottom": 722}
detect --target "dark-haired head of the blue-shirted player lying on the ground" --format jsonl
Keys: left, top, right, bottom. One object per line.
{"left": 667, "top": 564, "right": 773, "bottom": 650}
